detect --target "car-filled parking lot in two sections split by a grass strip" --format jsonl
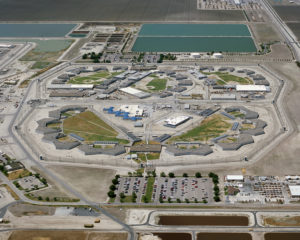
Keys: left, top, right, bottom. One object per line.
{"left": 115, "top": 177, "right": 213, "bottom": 203}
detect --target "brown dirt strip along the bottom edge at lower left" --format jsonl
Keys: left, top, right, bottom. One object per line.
{"left": 8, "top": 230, "right": 127, "bottom": 240}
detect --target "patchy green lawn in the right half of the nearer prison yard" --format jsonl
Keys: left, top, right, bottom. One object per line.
{"left": 168, "top": 114, "right": 231, "bottom": 142}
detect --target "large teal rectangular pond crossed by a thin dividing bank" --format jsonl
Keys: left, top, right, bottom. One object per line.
{"left": 132, "top": 24, "right": 257, "bottom": 52}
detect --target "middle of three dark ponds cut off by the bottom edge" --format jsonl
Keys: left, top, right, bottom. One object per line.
{"left": 197, "top": 233, "right": 252, "bottom": 240}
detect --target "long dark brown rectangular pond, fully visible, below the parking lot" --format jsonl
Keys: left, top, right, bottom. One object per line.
{"left": 158, "top": 215, "right": 249, "bottom": 226}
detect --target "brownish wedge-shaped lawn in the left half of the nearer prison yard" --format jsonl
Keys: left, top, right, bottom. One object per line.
{"left": 63, "top": 111, "right": 128, "bottom": 144}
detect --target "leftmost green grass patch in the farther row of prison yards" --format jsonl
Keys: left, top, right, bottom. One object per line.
{"left": 68, "top": 71, "right": 120, "bottom": 84}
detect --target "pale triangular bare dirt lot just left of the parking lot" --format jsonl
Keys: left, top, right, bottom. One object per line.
{"left": 48, "top": 165, "right": 115, "bottom": 202}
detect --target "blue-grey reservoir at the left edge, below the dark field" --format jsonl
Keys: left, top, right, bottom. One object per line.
{"left": 0, "top": 23, "right": 76, "bottom": 38}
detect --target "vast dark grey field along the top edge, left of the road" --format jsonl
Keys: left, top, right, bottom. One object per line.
{"left": 0, "top": 0, "right": 245, "bottom": 22}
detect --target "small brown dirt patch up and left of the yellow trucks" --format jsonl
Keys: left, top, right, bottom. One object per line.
{"left": 8, "top": 203, "right": 55, "bottom": 217}
